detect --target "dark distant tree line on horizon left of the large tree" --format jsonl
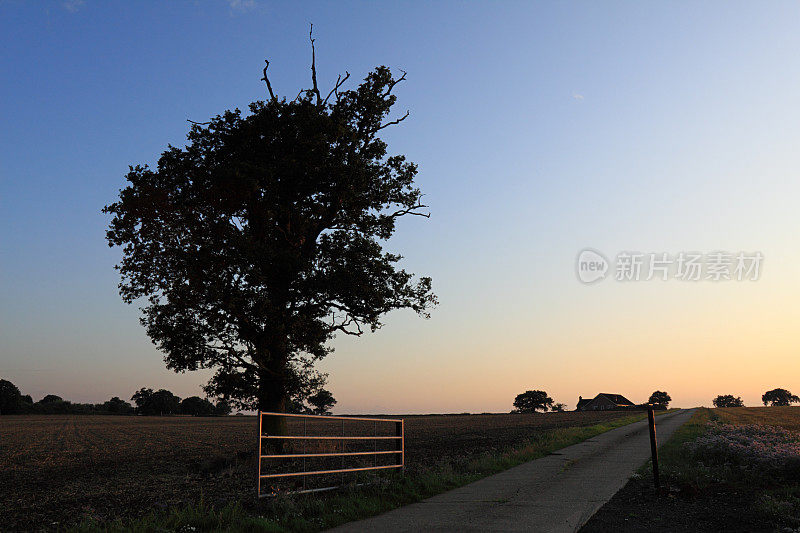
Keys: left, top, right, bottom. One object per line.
{"left": 0, "top": 379, "right": 233, "bottom": 416}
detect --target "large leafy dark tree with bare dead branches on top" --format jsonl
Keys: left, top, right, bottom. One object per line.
{"left": 104, "top": 31, "right": 436, "bottom": 420}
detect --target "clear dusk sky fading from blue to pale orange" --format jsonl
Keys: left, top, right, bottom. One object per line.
{"left": 0, "top": 0, "right": 800, "bottom": 413}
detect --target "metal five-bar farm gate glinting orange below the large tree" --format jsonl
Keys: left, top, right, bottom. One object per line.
{"left": 258, "top": 411, "right": 405, "bottom": 498}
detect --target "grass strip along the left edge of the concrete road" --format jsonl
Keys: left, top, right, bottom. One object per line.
{"left": 68, "top": 411, "right": 671, "bottom": 533}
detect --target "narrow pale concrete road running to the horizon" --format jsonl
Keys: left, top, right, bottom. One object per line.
{"left": 331, "top": 409, "right": 693, "bottom": 533}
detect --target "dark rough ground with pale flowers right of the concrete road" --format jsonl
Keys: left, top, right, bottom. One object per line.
{"left": 582, "top": 408, "right": 800, "bottom": 533}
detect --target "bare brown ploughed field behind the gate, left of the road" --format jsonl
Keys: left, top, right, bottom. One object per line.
{"left": 0, "top": 412, "right": 629, "bottom": 530}
